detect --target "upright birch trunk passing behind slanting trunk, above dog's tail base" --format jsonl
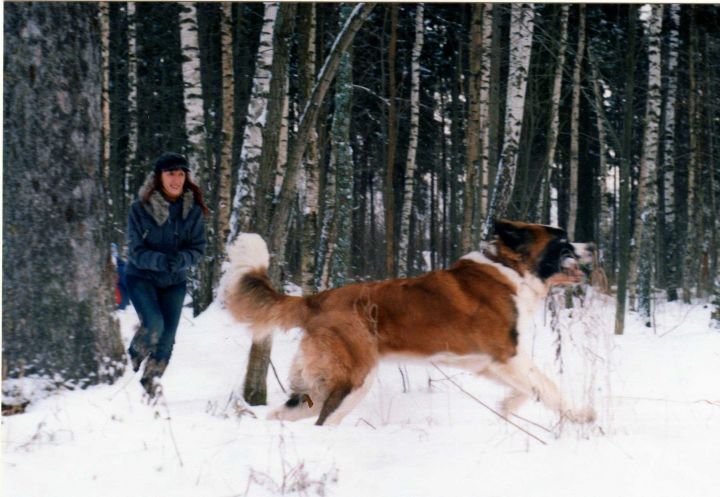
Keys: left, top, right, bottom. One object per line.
{"left": 298, "top": 3, "right": 320, "bottom": 295}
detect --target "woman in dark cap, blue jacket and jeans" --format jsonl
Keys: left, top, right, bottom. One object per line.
{"left": 125, "top": 153, "right": 208, "bottom": 398}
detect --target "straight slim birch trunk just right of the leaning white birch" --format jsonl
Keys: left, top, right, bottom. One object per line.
{"left": 661, "top": 4, "right": 680, "bottom": 301}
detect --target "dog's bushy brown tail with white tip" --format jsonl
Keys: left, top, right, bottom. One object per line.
{"left": 218, "top": 233, "right": 305, "bottom": 342}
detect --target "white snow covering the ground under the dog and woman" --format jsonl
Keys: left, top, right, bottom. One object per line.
{"left": 2, "top": 293, "right": 720, "bottom": 497}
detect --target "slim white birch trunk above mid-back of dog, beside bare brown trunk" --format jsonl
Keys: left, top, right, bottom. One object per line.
{"left": 398, "top": 3, "right": 424, "bottom": 278}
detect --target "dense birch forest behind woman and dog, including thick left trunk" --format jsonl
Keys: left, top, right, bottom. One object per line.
{"left": 2, "top": 2, "right": 720, "bottom": 399}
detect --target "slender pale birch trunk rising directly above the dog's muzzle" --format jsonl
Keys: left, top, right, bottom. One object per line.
{"left": 567, "top": 4, "right": 585, "bottom": 240}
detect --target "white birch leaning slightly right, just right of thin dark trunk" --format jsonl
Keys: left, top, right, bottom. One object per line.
{"left": 628, "top": 5, "right": 663, "bottom": 317}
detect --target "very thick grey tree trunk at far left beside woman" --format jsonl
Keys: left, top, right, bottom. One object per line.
{"left": 2, "top": 3, "right": 125, "bottom": 388}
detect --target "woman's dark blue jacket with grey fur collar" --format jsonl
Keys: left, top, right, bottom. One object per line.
{"left": 125, "top": 175, "right": 206, "bottom": 287}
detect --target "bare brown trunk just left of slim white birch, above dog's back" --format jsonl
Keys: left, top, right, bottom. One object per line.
{"left": 383, "top": 3, "right": 400, "bottom": 278}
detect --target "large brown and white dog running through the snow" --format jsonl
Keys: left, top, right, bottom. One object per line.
{"left": 221, "top": 221, "right": 595, "bottom": 425}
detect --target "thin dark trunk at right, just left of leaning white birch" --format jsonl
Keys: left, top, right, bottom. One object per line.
{"left": 615, "top": 4, "right": 637, "bottom": 335}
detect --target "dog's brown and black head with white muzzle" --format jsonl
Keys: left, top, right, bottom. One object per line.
{"left": 495, "top": 220, "right": 595, "bottom": 285}
